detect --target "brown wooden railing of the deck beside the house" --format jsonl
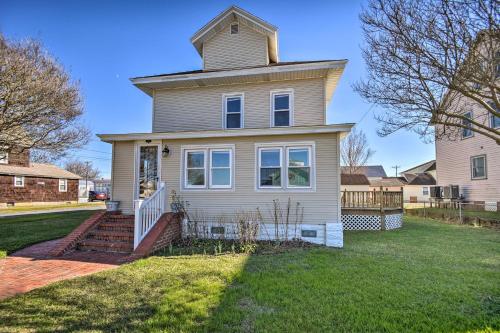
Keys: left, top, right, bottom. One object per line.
{"left": 341, "top": 188, "right": 403, "bottom": 210}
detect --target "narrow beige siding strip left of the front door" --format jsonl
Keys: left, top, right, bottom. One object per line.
{"left": 111, "top": 141, "right": 135, "bottom": 214}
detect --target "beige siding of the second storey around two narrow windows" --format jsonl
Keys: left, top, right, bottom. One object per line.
{"left": 153, "top": 78, "right": 325, "bottom": 132}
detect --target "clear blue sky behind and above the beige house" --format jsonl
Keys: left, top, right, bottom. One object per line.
{"left": 0, "top": 0, "right": 434, "bottom": 177}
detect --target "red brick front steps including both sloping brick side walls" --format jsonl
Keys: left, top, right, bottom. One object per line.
{"left": 49, "top": 212, "right": 181, "bottom": 261}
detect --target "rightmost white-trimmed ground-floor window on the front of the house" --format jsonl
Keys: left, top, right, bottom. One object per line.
{"left": 287, "top": 147, "right": 311, "bottom": 188}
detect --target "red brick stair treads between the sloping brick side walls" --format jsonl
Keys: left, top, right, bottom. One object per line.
{"left": 77, "top": 214, "right": 134, "bottom": 253}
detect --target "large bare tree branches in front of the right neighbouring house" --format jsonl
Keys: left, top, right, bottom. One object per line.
{"left": 354, "top": 0, "right": 500, "bottom": 144}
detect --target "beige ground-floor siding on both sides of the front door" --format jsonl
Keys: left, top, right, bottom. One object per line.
{"left": 113, "top": 134, "right": 339, "bottom": 224}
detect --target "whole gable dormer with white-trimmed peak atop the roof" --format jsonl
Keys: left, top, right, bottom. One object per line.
{"left": 191, "top": 6, "right": 278, "bottom": 70}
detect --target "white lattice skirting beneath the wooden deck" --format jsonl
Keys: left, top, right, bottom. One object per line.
{"left": 342, "top": 214, "right": 403, "bottom": 230}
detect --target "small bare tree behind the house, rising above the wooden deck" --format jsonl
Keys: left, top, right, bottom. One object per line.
{"left": 340, "top": 128, "right": 375, "bottom": 173}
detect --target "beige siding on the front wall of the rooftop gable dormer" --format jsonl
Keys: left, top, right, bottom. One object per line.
{"left": 203, "top": 23, "right": 269, "bottom": 70}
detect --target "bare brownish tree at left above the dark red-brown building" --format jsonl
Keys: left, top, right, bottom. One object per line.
{"left": 0, "top": 34, "right": 90, "bottom": 157}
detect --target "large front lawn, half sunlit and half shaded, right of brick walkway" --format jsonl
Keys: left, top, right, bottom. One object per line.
{"left": 0, "top": 219, "right": 500, "bottom": 332}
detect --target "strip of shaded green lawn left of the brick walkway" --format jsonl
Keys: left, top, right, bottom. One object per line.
{"left": 0, "top": 210, "right": 95, "bottom": 260}
